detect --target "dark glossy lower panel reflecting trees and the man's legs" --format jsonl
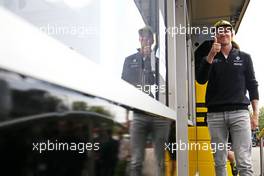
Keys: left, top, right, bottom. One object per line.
{"left": 0, "top": 69, "right": 171, "bottom": 176}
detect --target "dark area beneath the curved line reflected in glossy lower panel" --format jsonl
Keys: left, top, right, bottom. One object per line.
{"left": 0, "top": 115, "right": 130, "bottom": 176}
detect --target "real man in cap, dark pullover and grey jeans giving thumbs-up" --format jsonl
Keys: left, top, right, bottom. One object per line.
{"left": 197, "top": 20, "right": 259, "bottom": 176}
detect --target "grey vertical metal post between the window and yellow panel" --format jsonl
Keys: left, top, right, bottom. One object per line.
{"left": 175, "top": 0, "right": 189, "bottom": 176}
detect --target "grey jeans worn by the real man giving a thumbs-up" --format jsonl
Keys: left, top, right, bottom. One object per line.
{"left": 207, "top": 110, "right": 253, "bottom": 176}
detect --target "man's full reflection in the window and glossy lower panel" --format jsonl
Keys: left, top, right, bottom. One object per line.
{"left": 122, "top": 26, "right": 170, "bottom": 176}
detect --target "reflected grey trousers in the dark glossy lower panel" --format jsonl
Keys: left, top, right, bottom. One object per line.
{"left": 130, "top": 113, "right": 171, "bottom": 176}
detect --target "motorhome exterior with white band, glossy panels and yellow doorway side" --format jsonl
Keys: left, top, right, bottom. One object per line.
{"left": 0, "top": 0, "right": 254, "bottom": 176}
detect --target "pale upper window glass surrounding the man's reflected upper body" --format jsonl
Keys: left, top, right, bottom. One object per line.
{"left": 0, "top": 0, "right": 166, "bottom": 103}
